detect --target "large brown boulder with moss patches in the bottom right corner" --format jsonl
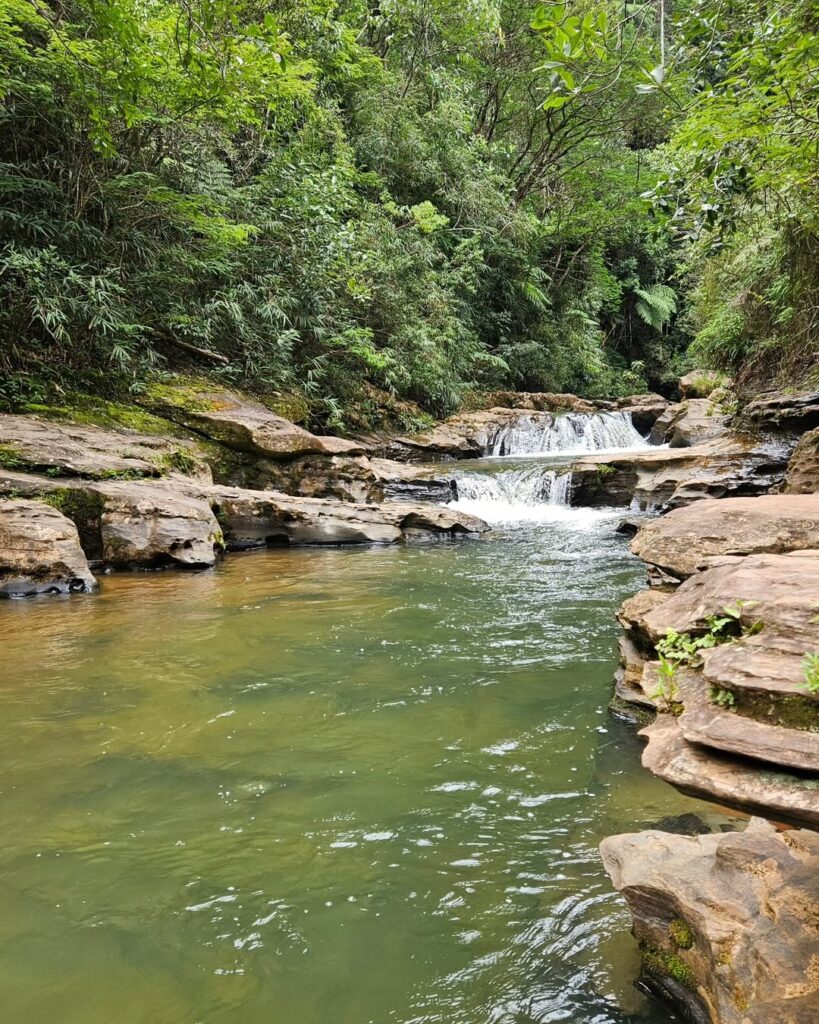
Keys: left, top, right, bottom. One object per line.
{"left": 600, "top": 818, "right": 819, "bottom": 1024}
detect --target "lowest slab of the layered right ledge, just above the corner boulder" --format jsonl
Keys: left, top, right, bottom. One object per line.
{"left": 640, "top": 715, "right": 819, "bottom": 828}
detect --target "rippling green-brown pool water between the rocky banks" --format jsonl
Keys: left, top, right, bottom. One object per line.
{"left": 0, "top": 518, "right": 724, "bottom": 1024}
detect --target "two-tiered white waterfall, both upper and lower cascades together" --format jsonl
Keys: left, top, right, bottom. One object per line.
{"left": 449, "top": 413, "right": 649, "bottom": 528}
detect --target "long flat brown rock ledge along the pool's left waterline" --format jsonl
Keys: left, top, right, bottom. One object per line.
{"left": 0, "top": 471, "right": 488, "bottom": 596}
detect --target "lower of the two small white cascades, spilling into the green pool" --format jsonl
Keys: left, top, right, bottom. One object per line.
{"left": 451, "top": 466, "right": 571, "bottom": 522}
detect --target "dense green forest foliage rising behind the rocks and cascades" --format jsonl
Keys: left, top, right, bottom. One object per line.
{"left": 0, "top": 0, "right": 819, "bottom": 427}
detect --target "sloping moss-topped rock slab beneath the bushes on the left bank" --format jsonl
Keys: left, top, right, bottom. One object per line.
{"left": 141, "top": 384, "right": 364, "bottom": 459}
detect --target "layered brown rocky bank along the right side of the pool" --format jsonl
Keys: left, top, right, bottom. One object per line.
{"left": 601, "top": 380, "right": 819, "bottom": 1024}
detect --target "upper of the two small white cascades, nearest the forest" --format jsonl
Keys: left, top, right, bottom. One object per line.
{"left": 487, "top": 413, "right": 648, "bottom": 456}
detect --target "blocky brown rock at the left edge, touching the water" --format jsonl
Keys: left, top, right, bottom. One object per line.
{"left": 0, "top": 499, "right": 96, "bottom": 597}
